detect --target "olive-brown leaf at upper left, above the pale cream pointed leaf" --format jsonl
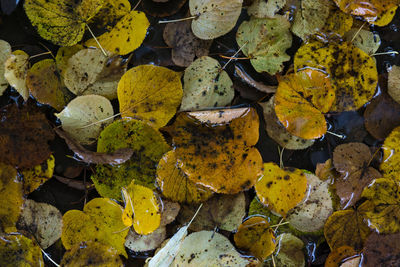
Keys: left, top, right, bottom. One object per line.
{"left": 26, "top": 59, "right": 72, "bottom": 110}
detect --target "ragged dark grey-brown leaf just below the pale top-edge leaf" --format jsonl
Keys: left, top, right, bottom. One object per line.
{"left": 163, "top": 21, "right": 212, "bottom": 67}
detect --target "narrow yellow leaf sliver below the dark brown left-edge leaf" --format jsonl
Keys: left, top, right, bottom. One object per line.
{"left": 20, "top": 155, "right": 55, "bottom": 195}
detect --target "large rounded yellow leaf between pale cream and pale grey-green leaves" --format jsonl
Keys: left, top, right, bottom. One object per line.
{"left": 118, "top": 65, "right": 183, "bottom": 128}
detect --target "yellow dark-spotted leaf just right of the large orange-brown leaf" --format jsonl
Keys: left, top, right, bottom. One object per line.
{"left": 254, "top": 162, "right": 307, "bottom": 216}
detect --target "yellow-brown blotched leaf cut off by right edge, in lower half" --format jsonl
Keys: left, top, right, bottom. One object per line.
{"left": 359, "top": 178, "right": 400, "bottom": 234}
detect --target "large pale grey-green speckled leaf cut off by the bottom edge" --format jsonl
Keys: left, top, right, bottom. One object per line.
{"left": 171, "top": 231, "right": 250, "bottom": 267}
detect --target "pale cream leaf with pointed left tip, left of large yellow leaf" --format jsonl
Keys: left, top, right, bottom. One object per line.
{"left": 55, "top": 95, "right": 114, "bottom": 145}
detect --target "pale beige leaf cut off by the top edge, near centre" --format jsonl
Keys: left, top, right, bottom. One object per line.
{"left": 189, "top": 0, "right": 243, "bottom": 40}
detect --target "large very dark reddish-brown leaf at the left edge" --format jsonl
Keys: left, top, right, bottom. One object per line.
{"left": 0, "top": 103, "right": 54, "bottom": 168}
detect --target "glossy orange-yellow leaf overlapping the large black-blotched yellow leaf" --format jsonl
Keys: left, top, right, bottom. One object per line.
{"left": 275, "top": 69, "right": 335, "bottom": 139}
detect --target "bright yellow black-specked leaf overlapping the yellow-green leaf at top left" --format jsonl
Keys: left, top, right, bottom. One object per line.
{"left": 85, "top": 11, "right": 150, "bottom": 55}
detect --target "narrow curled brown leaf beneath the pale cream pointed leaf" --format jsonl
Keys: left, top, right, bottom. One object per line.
{"left": 54, "top": 128, "right": 133, "bottom": 164}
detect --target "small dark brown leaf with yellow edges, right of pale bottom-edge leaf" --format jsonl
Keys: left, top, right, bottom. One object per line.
{"left": 234, "top": 216, "right": 276, "bottom": 260}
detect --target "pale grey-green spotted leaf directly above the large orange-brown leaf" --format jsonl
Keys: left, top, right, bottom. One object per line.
{"left": 181, "top": 57, "right": 235, "bottom": 110}
